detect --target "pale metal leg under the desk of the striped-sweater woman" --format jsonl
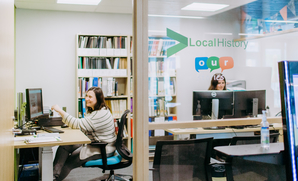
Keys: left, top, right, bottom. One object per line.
{"left": 39, "top": 147, "right": 53, "bottom": 181}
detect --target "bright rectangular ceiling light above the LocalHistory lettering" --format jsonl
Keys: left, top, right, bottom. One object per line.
{"left": 181, "top": 3, "right": 229, "bottom": 12}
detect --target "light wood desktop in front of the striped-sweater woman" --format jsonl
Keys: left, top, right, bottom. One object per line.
{"left": 14, "top": 126, "right": 91, "bottom": 148}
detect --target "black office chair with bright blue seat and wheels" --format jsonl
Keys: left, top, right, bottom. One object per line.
{"left": 84, "top": 110, "right": 132, "bottom": 181}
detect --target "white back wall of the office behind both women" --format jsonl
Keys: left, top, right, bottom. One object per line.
{"left": 16, "top": 9, "right": 298, "bottom": 120}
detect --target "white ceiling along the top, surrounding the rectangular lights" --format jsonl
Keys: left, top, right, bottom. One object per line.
{"left": 15, "top": 0, "right": 255, "bottom": 16}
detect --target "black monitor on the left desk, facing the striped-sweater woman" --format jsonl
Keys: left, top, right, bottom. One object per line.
{"left": 26, "top": 88, "right": 43, "bottom": 121}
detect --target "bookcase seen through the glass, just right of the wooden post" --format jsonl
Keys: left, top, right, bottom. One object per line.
{"left": 148, "top": 37, "right": 177, "bottom": 137}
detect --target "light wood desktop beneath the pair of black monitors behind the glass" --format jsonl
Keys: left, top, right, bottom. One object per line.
{"left": 165, "top": 123, "right": 282, "bottom": 135}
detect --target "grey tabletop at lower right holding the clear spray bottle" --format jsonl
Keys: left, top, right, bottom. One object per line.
{"left": 214, "top": 143, "right": 284, "bottom": 157}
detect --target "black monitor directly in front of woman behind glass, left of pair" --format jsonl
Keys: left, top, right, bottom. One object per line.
{"left": 192, "top": 90, "right": 233, "bottom": 119}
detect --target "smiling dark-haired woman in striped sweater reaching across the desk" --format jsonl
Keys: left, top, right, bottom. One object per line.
{"left": 51, "top": 87, "right": 116, "bottom": 181}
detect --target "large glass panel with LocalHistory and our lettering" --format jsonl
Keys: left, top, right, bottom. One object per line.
{"left": 148, "top": 0, "right": 298, "bottom": 180}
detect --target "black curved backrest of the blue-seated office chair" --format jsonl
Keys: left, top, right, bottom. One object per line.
{"left": 116, "top": 110, "right": 132, "bottom": 161}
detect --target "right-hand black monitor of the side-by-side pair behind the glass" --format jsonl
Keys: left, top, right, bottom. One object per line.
{"left": 234, "top": 90, "right": 266, "bottom": 118}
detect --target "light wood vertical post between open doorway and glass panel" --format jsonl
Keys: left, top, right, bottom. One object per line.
{"left": 133, "top": 0, "right": 149, "bottom": 181}
